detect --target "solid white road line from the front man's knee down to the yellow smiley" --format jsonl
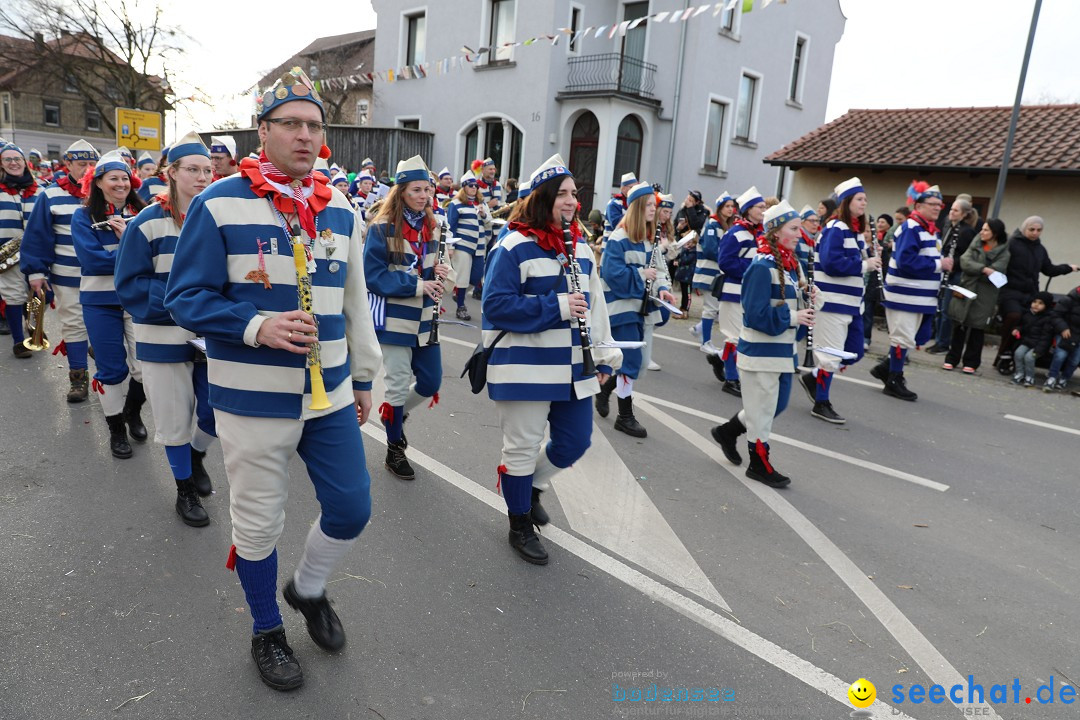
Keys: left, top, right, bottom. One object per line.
{"left": 362, "top": 422, "right": 913, "bottom": 720}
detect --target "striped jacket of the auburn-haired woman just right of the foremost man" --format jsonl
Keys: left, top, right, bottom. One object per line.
{"left": 364, "top": 222, "right": 438, "bottom": 348}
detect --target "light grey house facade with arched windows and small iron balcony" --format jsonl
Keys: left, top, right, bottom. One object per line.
{"left": 373, "top": 0, "right": 845, "bottom": 209}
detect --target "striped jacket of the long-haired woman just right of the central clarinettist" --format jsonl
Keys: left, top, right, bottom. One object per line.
{"left": 600, "top": 228, "right": 671, "bottom": 327}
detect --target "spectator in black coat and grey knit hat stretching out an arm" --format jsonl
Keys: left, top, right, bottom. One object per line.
{"left": 994, "top": 215, "right": 1080, "bottom": 365}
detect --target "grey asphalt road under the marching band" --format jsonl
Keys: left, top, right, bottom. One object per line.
{"left": 0, "top": 300, "right": 1080, "bottom": 720}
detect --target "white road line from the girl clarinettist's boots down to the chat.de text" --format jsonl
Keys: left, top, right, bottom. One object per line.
{"left": 637, "top": 395, "right": 998, "bottom": 718}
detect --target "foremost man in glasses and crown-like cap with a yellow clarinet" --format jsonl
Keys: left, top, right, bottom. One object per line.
{"left": 159, "top": 68, "right": 381, "bottom": 690}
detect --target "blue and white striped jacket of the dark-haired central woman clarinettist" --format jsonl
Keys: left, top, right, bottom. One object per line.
{"left": 482, "top": 231, "right": 622, "bottom": 400}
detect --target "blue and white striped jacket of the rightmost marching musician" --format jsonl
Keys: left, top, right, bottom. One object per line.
{"left": 881, "top": 218, "right": 942, "bottom": 315}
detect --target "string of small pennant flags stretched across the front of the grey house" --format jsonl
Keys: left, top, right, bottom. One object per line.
{"left": 251, "top": 0, "right": 787, "bottom": 105}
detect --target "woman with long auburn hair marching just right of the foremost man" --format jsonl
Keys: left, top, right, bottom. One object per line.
{"left": 364, "top": 155, "right": 450, "bottom": 480}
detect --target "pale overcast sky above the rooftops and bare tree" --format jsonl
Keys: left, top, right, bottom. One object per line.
{"left": 165, "top": 0, "right": 1080, "bottom": 139}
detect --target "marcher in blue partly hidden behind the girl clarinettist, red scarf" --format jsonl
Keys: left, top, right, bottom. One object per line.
{"left": 716, "top": 187, "right": 765, "bottom": 397}
